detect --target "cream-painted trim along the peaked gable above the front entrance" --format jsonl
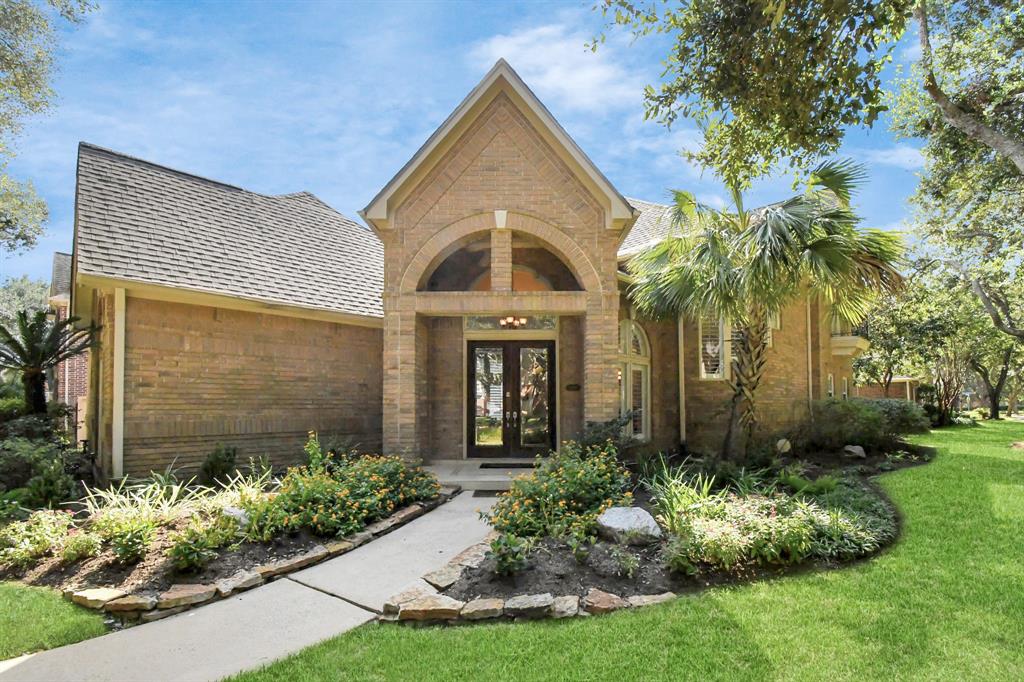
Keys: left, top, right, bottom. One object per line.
{"left": 359, "top": 59, "right": 636, "bottom": 227}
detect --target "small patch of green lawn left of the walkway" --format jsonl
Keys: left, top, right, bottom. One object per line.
{"left": 0, "top": 583, "right": 106, "bottom": 660}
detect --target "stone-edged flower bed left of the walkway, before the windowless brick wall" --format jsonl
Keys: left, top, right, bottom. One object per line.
{"left": 0, "top": 434, "right": 454, "bottom": 620}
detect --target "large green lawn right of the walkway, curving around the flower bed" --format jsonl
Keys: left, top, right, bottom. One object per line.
{"left": 234, "top": 422, "right": 1024, "bottom": 682}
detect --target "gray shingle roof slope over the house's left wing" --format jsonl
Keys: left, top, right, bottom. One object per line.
{"left": 76, "top": 143, "right": 384, "bottom": 317}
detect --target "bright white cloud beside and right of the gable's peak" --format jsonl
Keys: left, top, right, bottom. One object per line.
{"left": 470, "top": 24, "right": 644, "bottom": 113}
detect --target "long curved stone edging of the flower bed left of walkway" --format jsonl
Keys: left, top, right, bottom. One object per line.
{"left": 63, "top": 486, "right": 460, "bottom": 625}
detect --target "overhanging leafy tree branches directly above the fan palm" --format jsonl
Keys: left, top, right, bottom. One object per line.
{"left": 595, "top": 0, "right": 911, "bottom": 186}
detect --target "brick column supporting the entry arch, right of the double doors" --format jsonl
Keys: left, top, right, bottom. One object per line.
{"left": 583, "top": 292, "right": 618, "bottom": 422}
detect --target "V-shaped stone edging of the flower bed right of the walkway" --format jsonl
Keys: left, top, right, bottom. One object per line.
{"left": 378, "top": 532, "right": 676, "bottom": 624}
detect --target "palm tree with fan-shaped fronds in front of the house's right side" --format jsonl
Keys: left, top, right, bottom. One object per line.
{"left": 629, "top": 161, "right": 903, "bottom": 460}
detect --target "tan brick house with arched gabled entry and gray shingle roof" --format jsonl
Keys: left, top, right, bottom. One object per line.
{"left": 66, "top": 60, "right": 863, "bottom": 476}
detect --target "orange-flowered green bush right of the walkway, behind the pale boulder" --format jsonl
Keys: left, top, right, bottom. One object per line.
{"left": 481, "top": 443, "right": 632, "bottom": 538}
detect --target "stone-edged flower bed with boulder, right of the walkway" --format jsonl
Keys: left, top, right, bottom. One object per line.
{"left": 382, "top": 444, "right": 925, "bottom": 622}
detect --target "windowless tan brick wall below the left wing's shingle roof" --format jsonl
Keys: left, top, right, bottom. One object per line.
{"left": 119, "top": 298, "right": 382, "bottom": 474}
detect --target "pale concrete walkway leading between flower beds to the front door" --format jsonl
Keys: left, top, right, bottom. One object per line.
{"left": 0, "top": 493, "right": 494, "bottom": 682}
